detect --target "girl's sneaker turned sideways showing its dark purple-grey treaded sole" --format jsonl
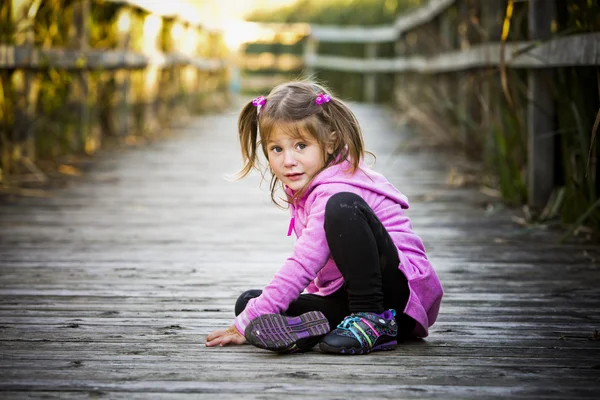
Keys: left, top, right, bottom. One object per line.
{"left": 244, "top": 311, "right": 329, "bottom": 353}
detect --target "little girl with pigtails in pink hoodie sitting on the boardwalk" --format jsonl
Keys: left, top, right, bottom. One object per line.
{"left": 206, "top": 82, "right": 443, "bottom": 354}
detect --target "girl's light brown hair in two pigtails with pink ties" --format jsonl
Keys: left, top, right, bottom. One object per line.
{"left": 237, "top": 81, "right": 365, "bottom": 205}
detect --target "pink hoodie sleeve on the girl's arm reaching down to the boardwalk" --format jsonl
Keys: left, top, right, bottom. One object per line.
{"left": 235, "top": 186, "right": 344, "bottom": 334}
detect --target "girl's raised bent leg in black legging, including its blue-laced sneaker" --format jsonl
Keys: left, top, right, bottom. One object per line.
{"left": 320, "top": 193, "right": 414, "bottom": 354}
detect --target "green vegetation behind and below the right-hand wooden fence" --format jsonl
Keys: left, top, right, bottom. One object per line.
{"left": 248, "top": 0, "right": 600, "bottom": 235}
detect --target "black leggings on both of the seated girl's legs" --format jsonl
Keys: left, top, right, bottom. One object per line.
{"left": 235, "top": 192, "right": 415, "bottom": 336}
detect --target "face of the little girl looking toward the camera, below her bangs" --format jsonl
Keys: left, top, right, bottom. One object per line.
{"left": 267, "top": 129, "right": 325, "bottom": 191}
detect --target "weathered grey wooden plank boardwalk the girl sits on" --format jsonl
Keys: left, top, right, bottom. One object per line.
{"left": 0, "top": 105, "right": 600, "bottom": 399}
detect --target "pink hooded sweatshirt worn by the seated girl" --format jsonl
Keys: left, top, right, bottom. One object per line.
{"left": 235, "top": 161, "right": 443, "bottom": 337}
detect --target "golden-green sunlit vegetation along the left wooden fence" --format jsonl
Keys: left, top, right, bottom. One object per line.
{"left": 0, "top": 0, "right": 225, "bottom": 193}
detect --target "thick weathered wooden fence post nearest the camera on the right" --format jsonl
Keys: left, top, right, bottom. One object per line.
{"left": 527, "top": 0, "right": 556, "bottom": 210}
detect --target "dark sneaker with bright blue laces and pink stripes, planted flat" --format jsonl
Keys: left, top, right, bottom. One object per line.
{"left": 319, "top": 310, "right": 398, "bottom": 354}
